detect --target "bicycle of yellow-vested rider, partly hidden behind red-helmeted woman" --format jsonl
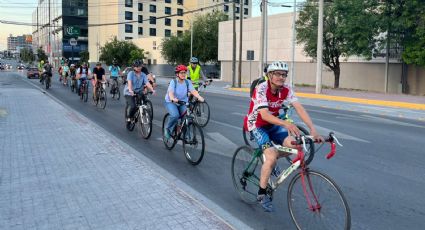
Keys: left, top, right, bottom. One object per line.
{"left": 189, "top": 79, "right": 212, "bottom": 127}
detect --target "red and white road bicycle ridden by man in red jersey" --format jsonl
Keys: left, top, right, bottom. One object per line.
{"left": 231, "top": 132, "right": 351, "bottom": 230}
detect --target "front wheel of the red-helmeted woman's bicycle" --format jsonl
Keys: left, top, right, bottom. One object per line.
{"left": 183, "top": 123, "right": 205, "bottom": 165}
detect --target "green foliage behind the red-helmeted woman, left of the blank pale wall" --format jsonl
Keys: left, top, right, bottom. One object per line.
{"left": 161, "top": 12, "right": 227, "bottom": 65}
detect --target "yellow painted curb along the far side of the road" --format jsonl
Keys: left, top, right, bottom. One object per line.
{"left": 229, "top": 88, "right": 425, "bottom": 110}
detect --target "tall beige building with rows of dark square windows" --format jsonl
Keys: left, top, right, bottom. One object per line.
{"left": 88, "top": 0, "right": 252, "bottom": 64}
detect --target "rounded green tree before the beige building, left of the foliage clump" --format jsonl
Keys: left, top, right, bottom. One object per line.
{"left": 99, "top": 37, "right": 144, "bottom": 66}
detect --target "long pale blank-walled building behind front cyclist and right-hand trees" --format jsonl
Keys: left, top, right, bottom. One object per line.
{"left": 218, "top": 13, "right": 425, "bottom": 95}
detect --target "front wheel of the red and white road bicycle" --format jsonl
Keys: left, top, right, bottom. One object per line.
{"left": 288, "top": 169, "right": 351, "bottom": 230}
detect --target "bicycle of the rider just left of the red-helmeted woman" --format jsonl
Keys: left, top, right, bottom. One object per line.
{"left": 125, "top": 92, "right": 152, "bottom": 139}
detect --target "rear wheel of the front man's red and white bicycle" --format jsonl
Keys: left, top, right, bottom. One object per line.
{"left": 231, "top": 145, "right": 263, "bottom": 204}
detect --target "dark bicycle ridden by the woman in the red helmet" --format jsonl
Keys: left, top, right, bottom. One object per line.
{"left": 162, "top": 101, "right": 205, "bottom": 165}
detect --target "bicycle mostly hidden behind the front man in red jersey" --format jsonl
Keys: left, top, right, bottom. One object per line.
{"left": 242, "top": 104, "right": 315, "bottom": 165}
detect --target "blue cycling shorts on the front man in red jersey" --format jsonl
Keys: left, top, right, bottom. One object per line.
{"left": 251, "top": 125, "right": 288, "bottom": 150}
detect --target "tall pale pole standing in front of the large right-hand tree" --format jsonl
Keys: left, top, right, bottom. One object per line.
{"left": 316, "top": 0, "right": 323, "bottom": 94}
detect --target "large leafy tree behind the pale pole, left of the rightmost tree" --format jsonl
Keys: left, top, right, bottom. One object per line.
{"left": 296, "top": 0, "right": 380, "bottom": 88}
